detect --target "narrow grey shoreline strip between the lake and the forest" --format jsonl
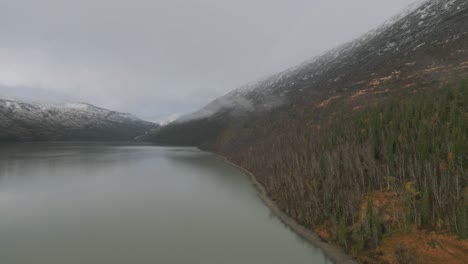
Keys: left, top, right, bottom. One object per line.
{"left": 220, "top": 155, "right": 358, "bottom": 264}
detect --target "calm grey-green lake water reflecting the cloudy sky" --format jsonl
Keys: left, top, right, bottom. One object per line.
{"left": 0, "top": 143, "right": 330, "bottom": 264}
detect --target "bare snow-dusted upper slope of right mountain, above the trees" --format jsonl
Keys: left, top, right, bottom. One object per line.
{"left": 149, "top": 0, "right": 468, "bottom": 144}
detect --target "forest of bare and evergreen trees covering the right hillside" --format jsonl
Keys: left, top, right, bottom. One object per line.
{"left": 215, "top": 82, "right": 468, "bottom": 261}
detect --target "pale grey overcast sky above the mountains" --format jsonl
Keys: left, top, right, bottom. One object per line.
{"left": 0, "top": 0, "right": 414, "bottom": 121}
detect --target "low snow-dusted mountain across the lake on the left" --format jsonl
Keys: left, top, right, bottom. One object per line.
{"left": 0, "top": 99, "right": 158, "bottom": 141}
